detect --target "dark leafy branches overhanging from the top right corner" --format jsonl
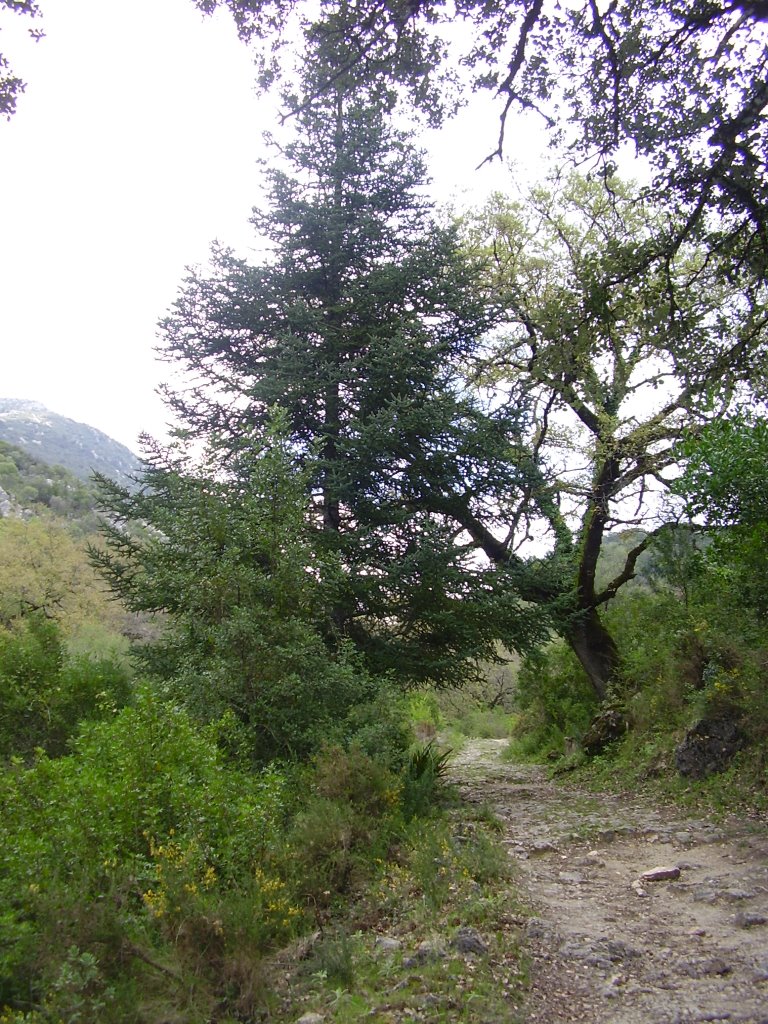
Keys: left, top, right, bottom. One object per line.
{"left": 202, "top": 0, "right": 768, "bottom": 272}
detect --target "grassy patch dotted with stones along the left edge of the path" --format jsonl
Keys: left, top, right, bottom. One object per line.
{"left": 259, "top": 808, "right": 527, "bottom": 1024}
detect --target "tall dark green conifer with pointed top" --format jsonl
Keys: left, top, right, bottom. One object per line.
{"left": 138, "top": 25, "right": 541, "bottom": 685}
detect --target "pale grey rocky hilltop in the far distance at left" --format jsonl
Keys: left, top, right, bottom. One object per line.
{"left": 0, "top": 398, "right": 140, "bottom": 483}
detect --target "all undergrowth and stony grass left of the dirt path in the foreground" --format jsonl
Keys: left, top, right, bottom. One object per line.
{"left": 0, "top": 689, "right": 522, "bottom": 1024}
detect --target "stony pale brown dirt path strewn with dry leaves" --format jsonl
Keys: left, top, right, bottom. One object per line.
{"left": 454, "top": 739, "right": 768, "bottom": 1024}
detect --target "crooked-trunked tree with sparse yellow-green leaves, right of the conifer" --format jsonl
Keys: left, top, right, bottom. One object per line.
{"left": 448, "top": 177, "right": 768, "bottom": 696}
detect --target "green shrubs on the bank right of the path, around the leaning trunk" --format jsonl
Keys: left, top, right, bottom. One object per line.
{"left": 510, "top": 512, "right": 768, "bottom": 810}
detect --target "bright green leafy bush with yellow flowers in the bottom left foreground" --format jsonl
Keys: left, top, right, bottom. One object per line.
{"left": 0, "top": 691, "right": 288, "bottom": 1022}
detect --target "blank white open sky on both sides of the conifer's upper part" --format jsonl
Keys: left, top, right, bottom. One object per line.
{"left": 0, "top": 0, "right": 544, "bottom": 451}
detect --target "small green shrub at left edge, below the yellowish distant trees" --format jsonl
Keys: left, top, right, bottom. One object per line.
{"left": 0, "top": 613, "right": 131, "bottom": 758}
